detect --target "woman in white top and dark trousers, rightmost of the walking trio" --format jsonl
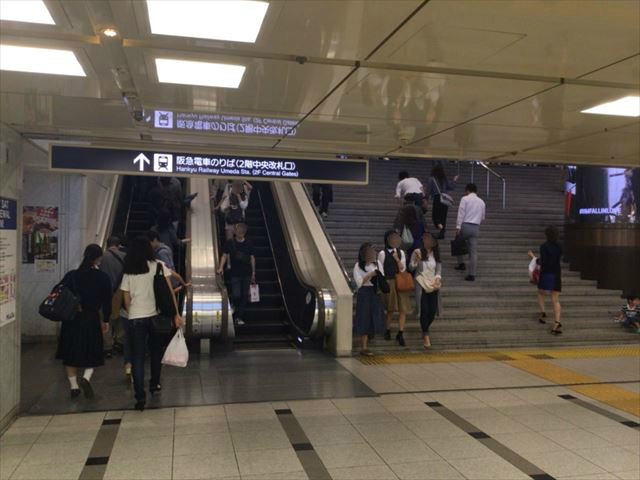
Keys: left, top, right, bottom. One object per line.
{"left": 409, "top": 232, "right": 442, "bottom": 349}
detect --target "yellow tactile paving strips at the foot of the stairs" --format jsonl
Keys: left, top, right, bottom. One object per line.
{"left": 360, "top": 345, "right": 640, "bottom": 417}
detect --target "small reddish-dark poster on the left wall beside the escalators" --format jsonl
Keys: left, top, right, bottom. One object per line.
{"left": 22, "top": 206, "right": 58, "bottom": 263}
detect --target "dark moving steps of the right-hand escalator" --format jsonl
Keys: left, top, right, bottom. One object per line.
{"left": 234, "top": 182, "right": 291, "bottom": 349}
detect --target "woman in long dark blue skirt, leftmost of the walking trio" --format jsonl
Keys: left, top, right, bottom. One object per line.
{"left": 353, "top": 243, "right": 383, "bottom": 356}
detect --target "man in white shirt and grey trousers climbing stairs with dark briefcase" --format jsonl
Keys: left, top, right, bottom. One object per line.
{"left": 455, "top": 183, "right": 486, "bottom": 282}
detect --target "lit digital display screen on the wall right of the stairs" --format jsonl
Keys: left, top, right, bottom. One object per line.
{"left": 565, "top": 166, "right": 640, "bottom": 223}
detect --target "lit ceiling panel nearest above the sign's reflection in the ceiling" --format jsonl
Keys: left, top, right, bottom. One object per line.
{"left": 156, "top": 58, "right": 246, "bottom": 88}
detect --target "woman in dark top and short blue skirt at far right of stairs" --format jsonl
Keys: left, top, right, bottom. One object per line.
{"left": 538, "top": 227, "right": 562, "bottom": 335}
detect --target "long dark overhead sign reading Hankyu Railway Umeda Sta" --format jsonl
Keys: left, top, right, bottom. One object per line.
{"left": 49, "top": 145, "right": 369, "bottom": 185}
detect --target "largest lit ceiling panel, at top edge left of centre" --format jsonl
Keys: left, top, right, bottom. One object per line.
{"left": 147, "top": 0, "right": 269, "bottom": 43}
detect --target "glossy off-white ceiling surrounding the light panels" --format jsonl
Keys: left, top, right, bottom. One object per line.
{"left": 0, "top": 0, "right": 640, "bottom": 165}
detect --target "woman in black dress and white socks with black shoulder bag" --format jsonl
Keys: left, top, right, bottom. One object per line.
{"left": 56, "top": 244, "right": 111, "bottom": 398}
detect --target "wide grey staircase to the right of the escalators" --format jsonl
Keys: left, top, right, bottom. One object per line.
{"left": 325, "top": 160, "right": 638, "bottom": 351}
